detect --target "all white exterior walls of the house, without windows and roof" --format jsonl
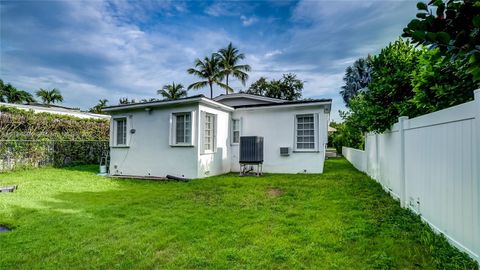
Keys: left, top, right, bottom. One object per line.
{"left": 110, "top": 102, "right": 329, "bottom": 178}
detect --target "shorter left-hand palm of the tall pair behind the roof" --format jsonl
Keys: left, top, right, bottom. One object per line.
{"left": 187, "top": 54, "right": 231, "bottom": 98}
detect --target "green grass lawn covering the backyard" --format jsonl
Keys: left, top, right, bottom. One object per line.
{"left": 0, "top": 159, "right": 478, "bottom": 269}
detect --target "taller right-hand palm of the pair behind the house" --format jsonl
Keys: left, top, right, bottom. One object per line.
{"left": 217, "top": 42, "right": 250, "bottom": 94}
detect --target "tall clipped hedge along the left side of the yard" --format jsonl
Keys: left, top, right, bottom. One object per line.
{"left": 0, "top": 106, "right": 109, "bottom": 171}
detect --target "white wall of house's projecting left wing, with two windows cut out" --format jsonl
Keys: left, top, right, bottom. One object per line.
{"left": 110, "top": 105, "right": 198, "bottom": 178}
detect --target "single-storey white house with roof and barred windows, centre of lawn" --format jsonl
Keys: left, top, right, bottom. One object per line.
{"left": 104, "top": 93, "right": 332, "bottom": 178}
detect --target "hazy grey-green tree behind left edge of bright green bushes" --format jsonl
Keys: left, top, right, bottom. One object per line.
{"left": 340, "top": 55, "right": 373, "bottom": 107}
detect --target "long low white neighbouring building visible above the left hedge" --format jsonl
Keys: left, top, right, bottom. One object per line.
{"left": 0, "top": 102, "right": 110, "bottom": 119}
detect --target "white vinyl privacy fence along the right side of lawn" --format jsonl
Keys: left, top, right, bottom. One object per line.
{"left": 342, "top": 90, "right": 480, "bottom": 262}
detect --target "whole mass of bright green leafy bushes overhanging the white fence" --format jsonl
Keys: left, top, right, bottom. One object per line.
{"left": 349, "top": 39, "right": 480, "bottom": 132}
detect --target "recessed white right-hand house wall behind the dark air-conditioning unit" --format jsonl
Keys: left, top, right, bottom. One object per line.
{"left": 231, "top": 106, "right": 329, "bottom": 173}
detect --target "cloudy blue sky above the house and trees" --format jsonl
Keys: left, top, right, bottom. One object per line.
{"left": 0, "top": 0, "right": 416, "bottom": 119}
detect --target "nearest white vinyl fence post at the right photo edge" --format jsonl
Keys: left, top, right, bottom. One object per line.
{"left": 473, "top": 89, "right": 480, "bottom": 263}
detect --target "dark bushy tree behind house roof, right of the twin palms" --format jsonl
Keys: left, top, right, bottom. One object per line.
{"left": 246, "top": 73, "right": 303, "bottom": 100}
